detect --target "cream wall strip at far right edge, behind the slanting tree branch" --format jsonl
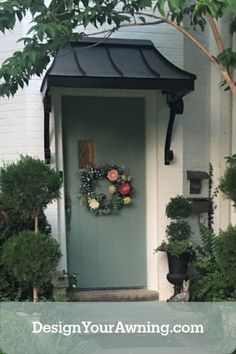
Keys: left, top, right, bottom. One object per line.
{"left": 210, "top": 16, "right": 236, "bottom": 231}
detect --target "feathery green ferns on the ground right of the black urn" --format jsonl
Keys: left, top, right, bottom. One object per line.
{"left": 190, "top": 224, "right": 236, "bottom": 301}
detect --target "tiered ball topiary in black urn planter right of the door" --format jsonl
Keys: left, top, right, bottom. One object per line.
{"left": 155, "top": 195, "right": 194, "bottom": 296}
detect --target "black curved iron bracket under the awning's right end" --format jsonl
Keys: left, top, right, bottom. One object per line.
{"left": 165, "top": 95, "right": 184, "bottom": 165}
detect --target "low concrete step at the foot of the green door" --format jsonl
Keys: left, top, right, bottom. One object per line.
{"left": 71, "top": 289, "right": 159, "bottom": 302}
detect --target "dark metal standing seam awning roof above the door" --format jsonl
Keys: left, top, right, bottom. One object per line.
{"left": 41, "top": 38, "right": 196, "bottom": 96}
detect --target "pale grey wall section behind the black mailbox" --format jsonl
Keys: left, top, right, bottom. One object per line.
{"left": 180, "top": 23, "right": 211, "bottom": 242}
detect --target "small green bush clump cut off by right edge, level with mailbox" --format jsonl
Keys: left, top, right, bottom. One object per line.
{"left": 219, "top": 155, "right": 236, "bottom": 206}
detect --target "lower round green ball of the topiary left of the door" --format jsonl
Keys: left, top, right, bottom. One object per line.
{"left": 2, "top": 231, "right": 61, "bottom": 302}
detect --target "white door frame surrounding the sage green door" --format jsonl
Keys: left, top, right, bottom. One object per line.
{"left": 50, "top": 88, "right": 162, "bottom": 290}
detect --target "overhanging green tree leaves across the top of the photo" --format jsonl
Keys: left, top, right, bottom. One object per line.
{"left": 0, "top": 0, "right": 236, "bottom": 96}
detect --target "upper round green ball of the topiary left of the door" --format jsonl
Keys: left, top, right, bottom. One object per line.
{"left": 0, "top": 156, "right": 62, "bottom": 232}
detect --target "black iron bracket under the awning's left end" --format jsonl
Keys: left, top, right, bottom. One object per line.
{"left": 43, "top": 95, "right": 51, "bottom": 165}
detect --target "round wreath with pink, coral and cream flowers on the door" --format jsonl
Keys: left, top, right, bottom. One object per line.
{"left": 80, "top": 165, "right": 133, "bottom": 215}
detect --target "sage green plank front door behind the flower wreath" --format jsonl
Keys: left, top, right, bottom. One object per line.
{"left": 62, "top": 96, "right": 146, "bottom": 288}
